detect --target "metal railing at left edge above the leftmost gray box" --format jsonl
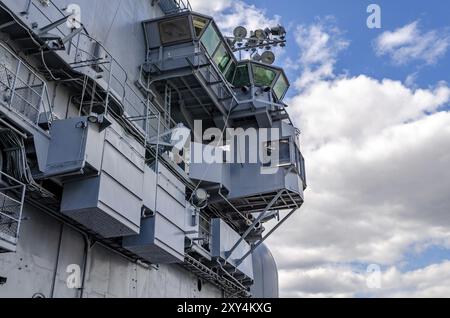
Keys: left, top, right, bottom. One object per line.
{"left": 0, "top": 43, "right": 51, "bottom": 125}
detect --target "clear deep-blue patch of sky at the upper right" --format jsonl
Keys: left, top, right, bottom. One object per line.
{"left": 247, "top": 0, "right": 450, "bottom": 86}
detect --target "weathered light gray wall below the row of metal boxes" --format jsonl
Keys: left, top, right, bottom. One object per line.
{"left": 0, "top": 206, "right": 222, "bottom": 298}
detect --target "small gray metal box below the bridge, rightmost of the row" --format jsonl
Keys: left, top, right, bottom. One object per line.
{"left": 211, "top": 219, "right": 253, "bottom": 279}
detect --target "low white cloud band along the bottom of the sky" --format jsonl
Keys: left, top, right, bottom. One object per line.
{"left": 280, "top": 261, "right": 450, "bottom": 298}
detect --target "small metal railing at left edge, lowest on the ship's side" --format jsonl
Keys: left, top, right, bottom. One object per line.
{"left": 0, "top": 171, "right": 26, "bottom": 250}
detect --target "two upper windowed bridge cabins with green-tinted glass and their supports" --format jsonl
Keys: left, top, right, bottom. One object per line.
{"left": 144, "top": 12, "right": 289, "bottom": 129}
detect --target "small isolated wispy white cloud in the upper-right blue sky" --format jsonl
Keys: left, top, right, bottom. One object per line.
{"left": 375, "top": 21, "right": 450, "bottom": 65}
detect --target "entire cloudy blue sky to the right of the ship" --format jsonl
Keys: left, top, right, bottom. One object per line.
{"left": 191, "top": 0, "right": 450, "bottom": 297}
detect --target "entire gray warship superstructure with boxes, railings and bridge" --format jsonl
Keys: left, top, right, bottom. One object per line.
{"left": 0, "top": 0, "right": 306, "bottom": 298}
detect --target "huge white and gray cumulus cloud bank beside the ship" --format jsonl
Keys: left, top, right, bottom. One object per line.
{"left": 270, "top": 17, "right": 450, "bottom": 297}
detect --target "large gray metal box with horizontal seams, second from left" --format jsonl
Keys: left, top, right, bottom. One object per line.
{"left": 61, "top": 119, "right": 145, "bottom": 238}
